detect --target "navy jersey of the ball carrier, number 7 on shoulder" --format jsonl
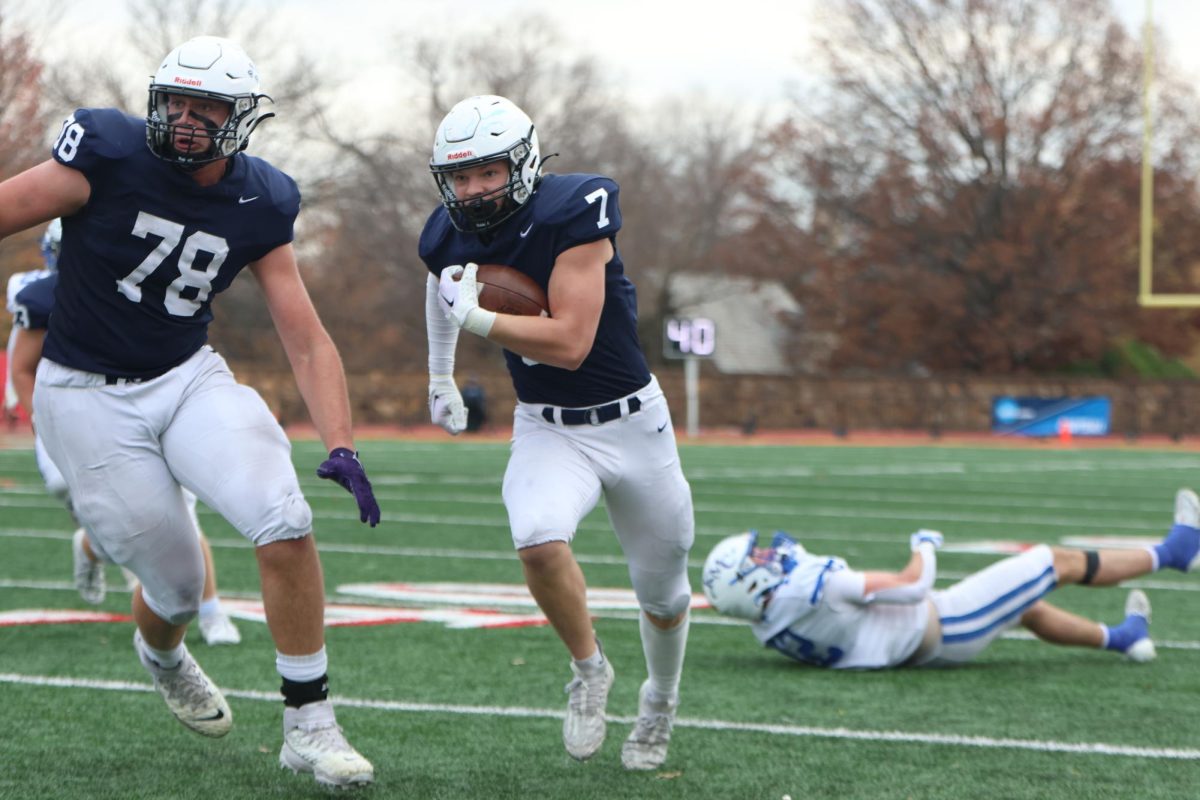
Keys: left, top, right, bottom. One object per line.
{"left": 420, "top": 175, "right": 650, "bottom": 408}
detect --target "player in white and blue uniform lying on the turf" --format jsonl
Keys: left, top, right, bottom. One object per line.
{"left": 703, "top": 489, "right": 1200, "bottom": 669}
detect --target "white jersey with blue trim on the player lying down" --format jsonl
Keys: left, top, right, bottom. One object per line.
{"left": 754, "top": 554, "right": 929, "bottom": 669}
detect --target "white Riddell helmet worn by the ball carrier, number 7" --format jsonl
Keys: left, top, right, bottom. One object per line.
{"left": 430, "top": 95, "right": 541, "bottom": 233}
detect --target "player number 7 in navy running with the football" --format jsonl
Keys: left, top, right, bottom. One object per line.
{"left": 420, "top": 96, "right": 694, "bottom": 769}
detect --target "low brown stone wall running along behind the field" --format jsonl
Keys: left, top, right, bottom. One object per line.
{"left": 235, "top": 366, "right": 1200, "bottom": 437}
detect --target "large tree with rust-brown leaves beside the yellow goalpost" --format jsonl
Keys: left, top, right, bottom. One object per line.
{"left": 748, "top": 0, "right": 1200, "bottom": 371}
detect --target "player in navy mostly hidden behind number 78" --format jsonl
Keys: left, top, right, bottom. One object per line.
{"left": 7, "top": 226, "right": 241, "bottom": 644}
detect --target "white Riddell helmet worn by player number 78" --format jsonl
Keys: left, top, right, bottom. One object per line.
{"left": 146, "top": 36, "right": 275, "bottom": 168}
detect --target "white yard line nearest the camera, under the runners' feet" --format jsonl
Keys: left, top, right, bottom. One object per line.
{"left": 0, "top": 673, "right": 1200, "bottom": 762}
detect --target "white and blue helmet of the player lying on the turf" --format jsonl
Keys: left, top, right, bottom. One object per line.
{"left": 703, "top": 530, "right": 804, "bottom": 622}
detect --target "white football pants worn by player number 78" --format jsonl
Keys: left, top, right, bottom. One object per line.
{"left": 34, "top": 347, "right": 312, "bottom": 624}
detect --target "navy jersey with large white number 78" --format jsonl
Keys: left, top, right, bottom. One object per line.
{"left": 42, "top": 109, "right": 300, "bottom": 378}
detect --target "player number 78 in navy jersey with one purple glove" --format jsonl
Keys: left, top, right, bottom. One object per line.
{"left": 0, "top": 36, "right": 379, "bottom": 786}
